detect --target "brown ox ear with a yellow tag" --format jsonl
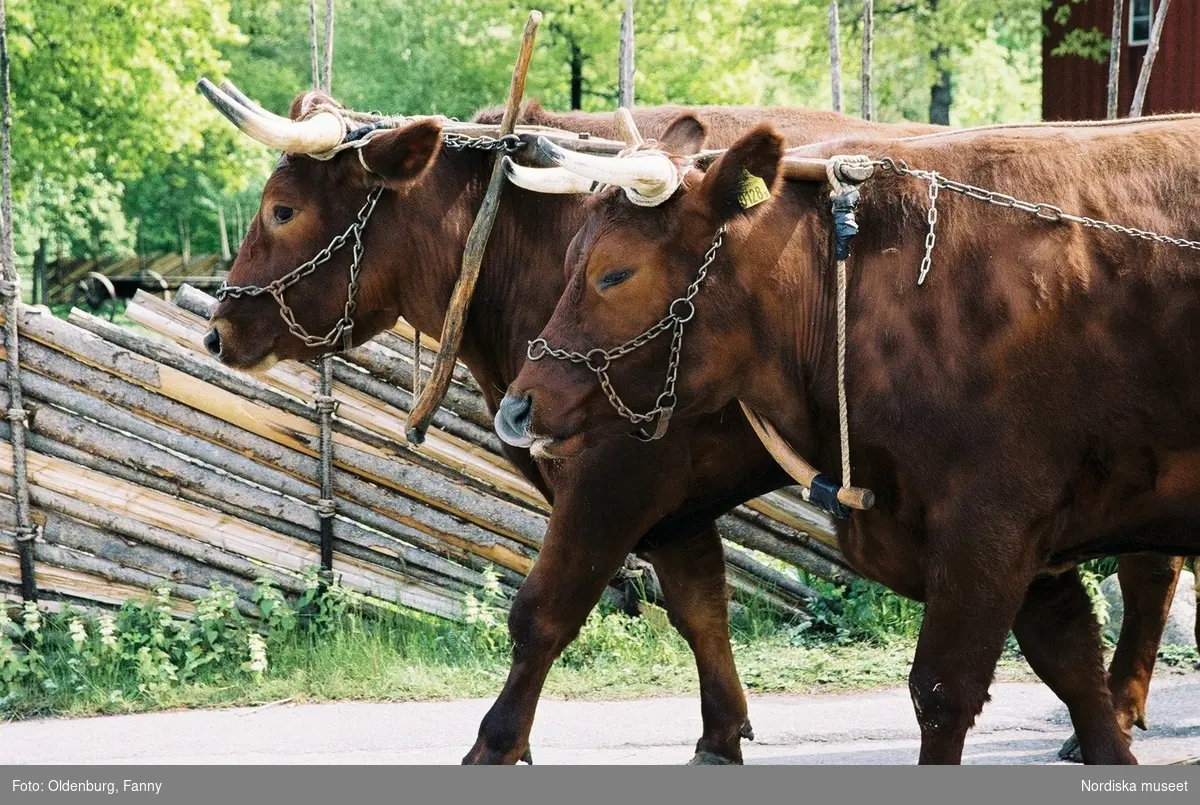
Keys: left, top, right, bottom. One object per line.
{"left": 700, "top": 124, "right": 784, "bottom": 223}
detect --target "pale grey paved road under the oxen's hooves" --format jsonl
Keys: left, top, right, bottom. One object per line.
{"left": 0, "top": 674, "right": 1200, "bottom": 764}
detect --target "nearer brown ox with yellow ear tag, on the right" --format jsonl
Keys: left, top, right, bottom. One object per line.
{"left": 509, "top": 118, "right": 1200, "bottom": 763}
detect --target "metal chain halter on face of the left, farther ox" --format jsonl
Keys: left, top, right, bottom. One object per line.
{"left": 215, "top": 130, "right": 524, "bottom": 350}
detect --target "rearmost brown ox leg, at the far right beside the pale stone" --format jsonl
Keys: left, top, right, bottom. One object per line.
{"left": 1058, "top": 553, "right": 1183, "bottom": 762}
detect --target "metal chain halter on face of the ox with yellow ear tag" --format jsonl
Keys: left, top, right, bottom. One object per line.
{"left": 526, "top": 226, "right": 725, "bottom": 441}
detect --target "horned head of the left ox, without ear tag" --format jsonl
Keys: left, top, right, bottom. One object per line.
{"left": 202, "top": 83, "right": 442, "bottom": 371}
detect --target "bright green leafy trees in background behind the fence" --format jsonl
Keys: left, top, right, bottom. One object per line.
{"left": 10, "top": 0, "right": 1041, "bottom": 275}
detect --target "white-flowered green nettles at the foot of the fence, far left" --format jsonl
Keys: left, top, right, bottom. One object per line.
{"left": 0, "top": 570, "right": 355, "bottom": 711}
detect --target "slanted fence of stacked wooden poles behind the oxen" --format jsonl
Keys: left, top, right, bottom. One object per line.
{"left": 0, "top": 287, "right": 852, "bottom": 619}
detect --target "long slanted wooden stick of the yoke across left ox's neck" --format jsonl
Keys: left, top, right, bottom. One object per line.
{"left": 404, "top": 11, "right": 541, "bottom": 444}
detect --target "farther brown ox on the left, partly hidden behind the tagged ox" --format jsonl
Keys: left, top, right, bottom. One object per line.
{"left": 196, "top": 86, "right": 1170, "bottom": 763}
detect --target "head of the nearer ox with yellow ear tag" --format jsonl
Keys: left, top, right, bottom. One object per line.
{"left": 496, "top": 126, "right": 784, "bottom": 457}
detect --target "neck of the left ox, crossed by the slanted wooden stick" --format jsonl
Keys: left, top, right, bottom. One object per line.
{"left": 389, "top": 151, "right": 586, "bottom": 404}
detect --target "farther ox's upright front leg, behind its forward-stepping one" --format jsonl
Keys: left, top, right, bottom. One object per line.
{"left": 647, "top": 525, "right": 754, "bottom": 764}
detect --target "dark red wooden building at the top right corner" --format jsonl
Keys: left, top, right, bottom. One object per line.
{"left": 1042, "top": 0, "right": 1200, "bottom": 120}
